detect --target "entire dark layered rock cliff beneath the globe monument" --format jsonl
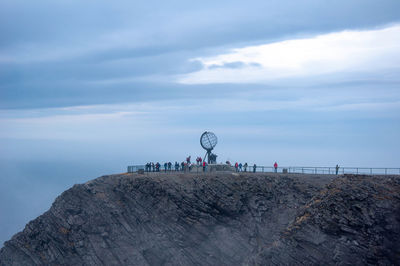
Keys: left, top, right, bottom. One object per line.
{"left": 0, "top": 173, "right": 400, "bottom": 265}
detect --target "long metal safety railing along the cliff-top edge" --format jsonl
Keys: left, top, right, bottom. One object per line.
{"left": 128, "top": 164, "right": 400, "bottom": 175}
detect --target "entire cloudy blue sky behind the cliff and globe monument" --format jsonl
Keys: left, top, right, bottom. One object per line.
{"left": 0, "top": 0, "right": 400, "bottom": 246}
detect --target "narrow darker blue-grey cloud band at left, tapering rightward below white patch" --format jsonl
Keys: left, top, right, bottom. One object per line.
{"left": 0, "top": 80, "right": 268, "bottom": 109}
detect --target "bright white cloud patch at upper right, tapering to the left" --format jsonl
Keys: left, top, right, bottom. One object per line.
{"left": 178, "top": 25, "right": 400, "bottom": 84}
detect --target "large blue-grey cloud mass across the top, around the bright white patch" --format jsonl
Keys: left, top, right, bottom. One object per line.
{"left": 0, "top": 0, "right": 400, "bottom": 107}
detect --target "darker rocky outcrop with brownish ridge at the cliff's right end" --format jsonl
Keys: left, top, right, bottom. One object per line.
{"left": 250, "top": 176, "right": 400, "bottom": 265}
